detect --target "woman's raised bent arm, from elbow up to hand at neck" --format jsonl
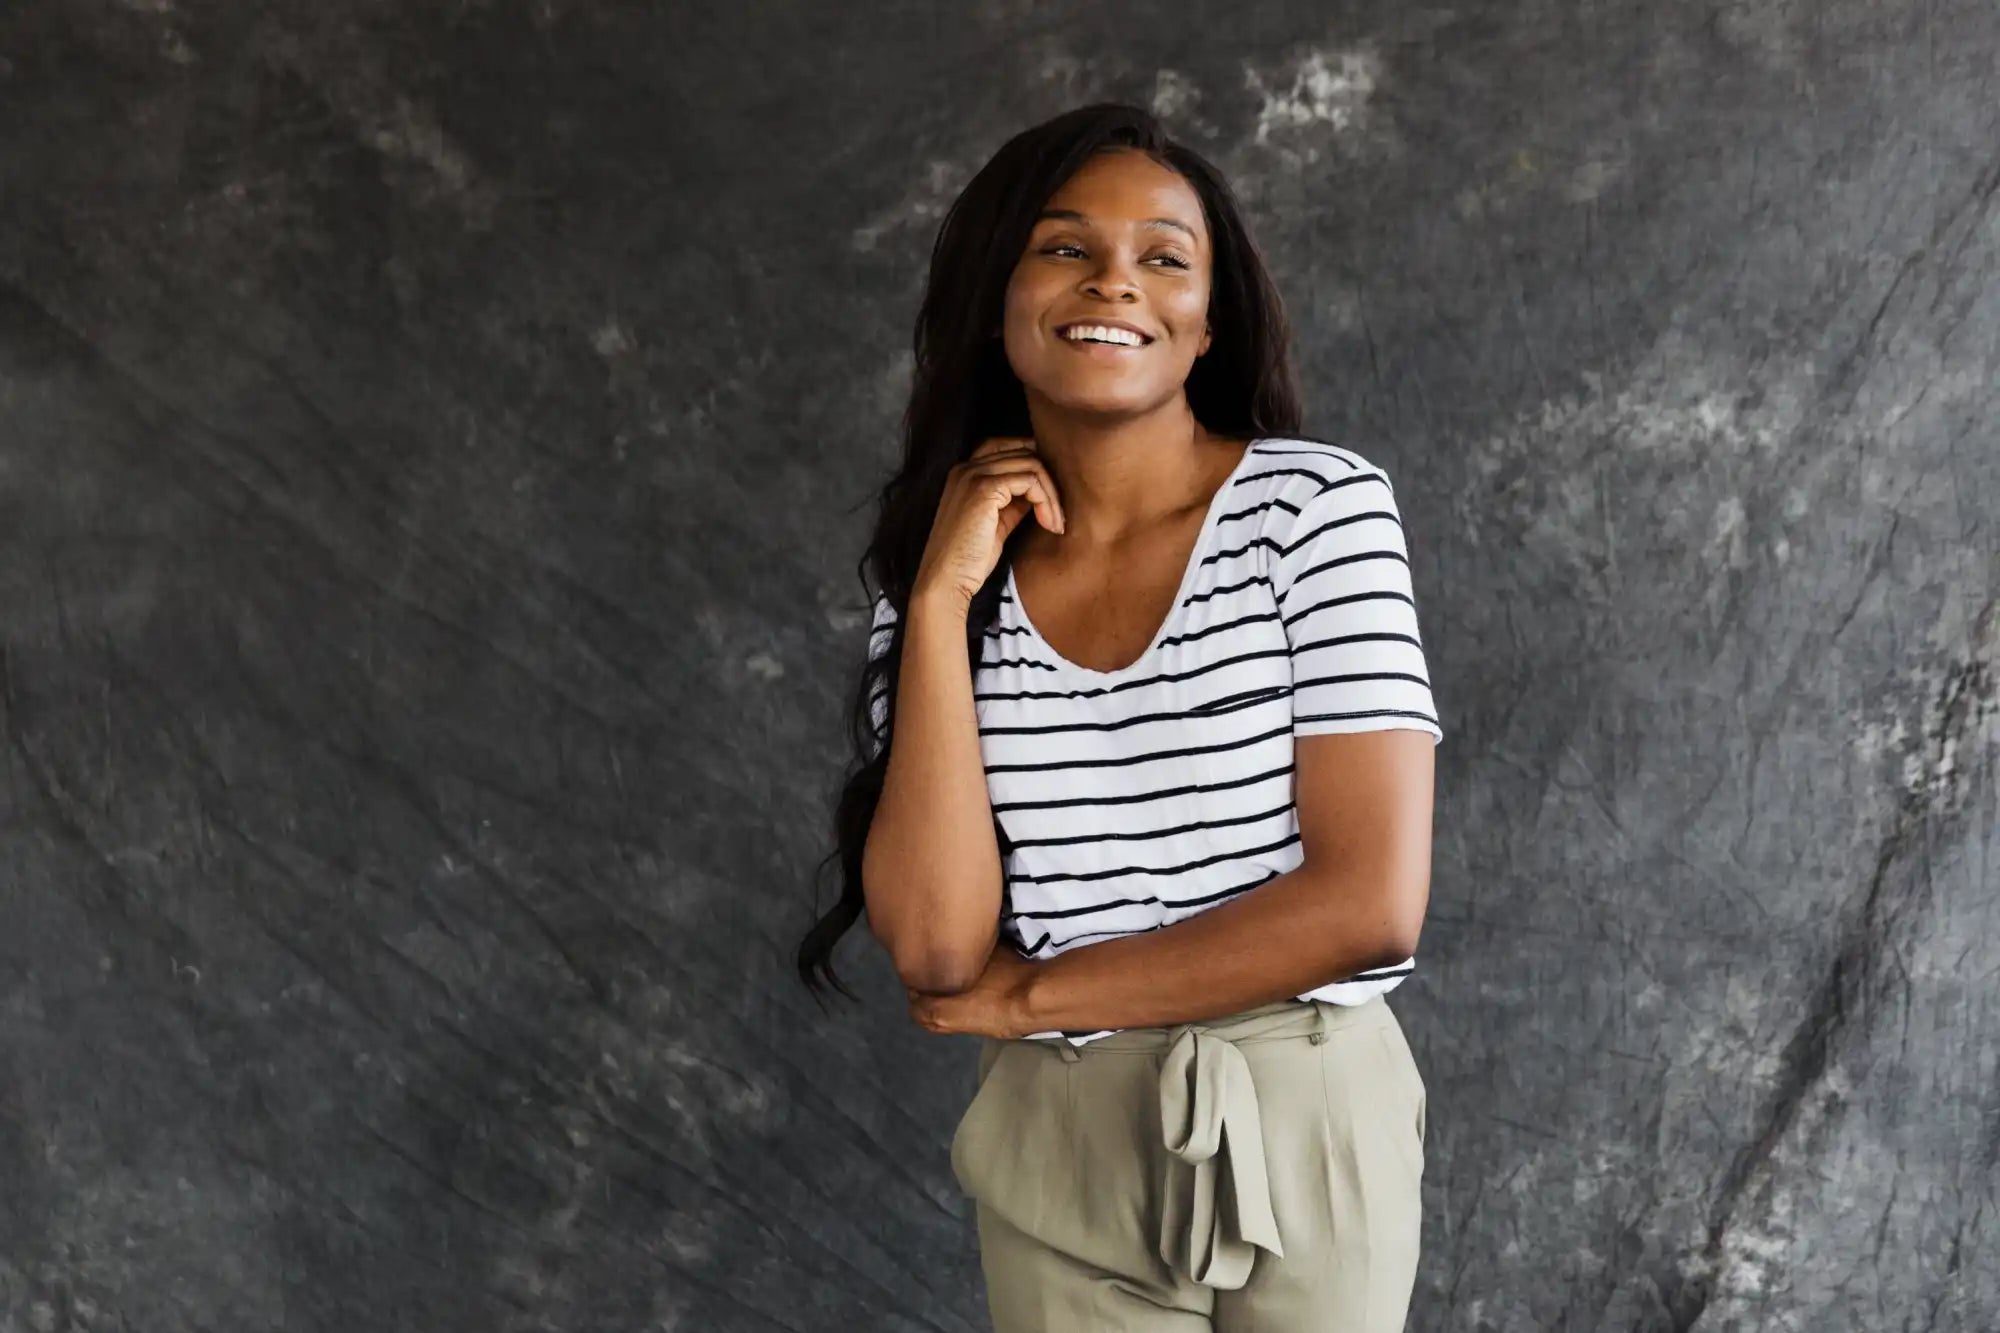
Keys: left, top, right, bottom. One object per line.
{"left": 862, "top": 436, "right": 1064, "bottom": 995}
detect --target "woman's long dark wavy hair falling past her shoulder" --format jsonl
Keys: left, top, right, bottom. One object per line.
{"left": 798, "top": 102, "right": 1302, "bottom": 999}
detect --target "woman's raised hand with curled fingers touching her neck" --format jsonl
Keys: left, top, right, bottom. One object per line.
{"left": 912, "top": 434, "right": 1064, "bottom": 606}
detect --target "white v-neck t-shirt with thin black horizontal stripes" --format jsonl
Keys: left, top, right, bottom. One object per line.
{"left": 868, "top": 438, "right": 1444, "bottom": 1045}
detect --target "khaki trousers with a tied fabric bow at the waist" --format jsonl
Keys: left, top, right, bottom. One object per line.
{"left": 952, "top": 997, "right": 1426, "bottom": 1333}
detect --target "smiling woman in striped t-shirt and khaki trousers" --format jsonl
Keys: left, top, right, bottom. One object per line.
{"left": 800, "top": 104, "right": 1444, "bottom": 1333}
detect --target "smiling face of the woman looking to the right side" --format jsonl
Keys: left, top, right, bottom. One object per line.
{"left": 1004, "top": 150, "right": 1210, "bottom": 412}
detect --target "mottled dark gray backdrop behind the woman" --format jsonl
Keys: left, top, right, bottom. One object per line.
{"left": 0, "top": 0, "right": 2000, "bottom": 1333}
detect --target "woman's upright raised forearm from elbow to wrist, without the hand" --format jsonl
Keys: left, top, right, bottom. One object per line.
{"left": 862, "top": 596, "right": 1002, "bottom": 991}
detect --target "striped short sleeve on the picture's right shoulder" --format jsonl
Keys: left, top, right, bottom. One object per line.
{"left": 1270, "top": 464, "right": 1444, "bottom": 745}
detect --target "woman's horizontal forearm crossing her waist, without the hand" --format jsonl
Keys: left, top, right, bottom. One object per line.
{"left": 1022, "top": 865, "right": 1414, "bottom": 1033}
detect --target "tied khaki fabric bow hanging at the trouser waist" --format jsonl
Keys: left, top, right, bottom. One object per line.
{"left": 1160, "top": 1027, "right": 1284, "bottom": 1291}
